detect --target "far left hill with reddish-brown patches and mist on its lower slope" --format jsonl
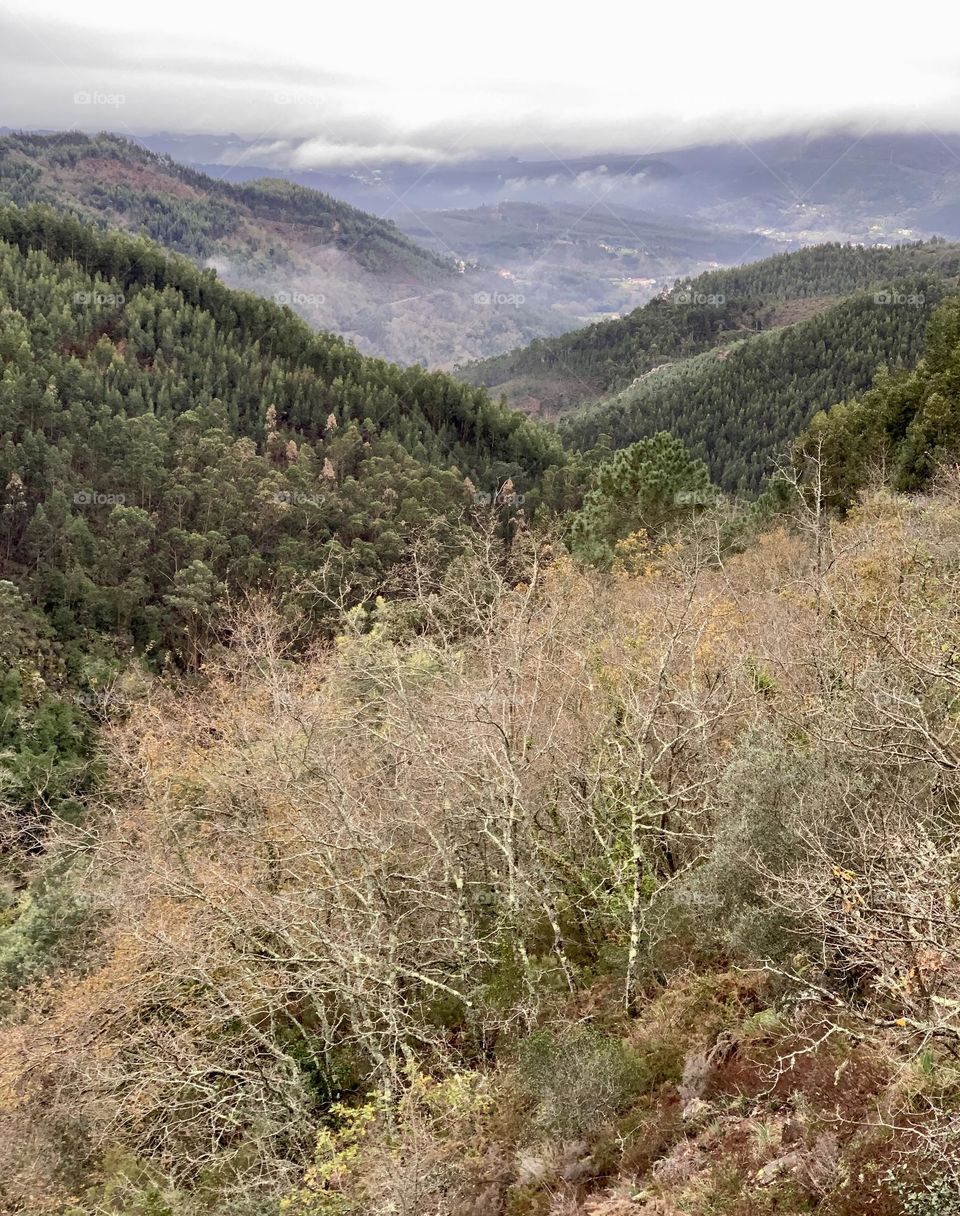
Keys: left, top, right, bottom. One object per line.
{"left": 0, "top": 133, "right": 568, "bottom": 366}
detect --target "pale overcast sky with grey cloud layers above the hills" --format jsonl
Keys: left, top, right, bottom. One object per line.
{"left": 0, "top": 0, "right": 960, "bottom": 168}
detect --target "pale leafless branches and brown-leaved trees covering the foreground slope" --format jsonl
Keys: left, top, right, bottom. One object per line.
{"left": 0, "top": 488, "right": 960, "bottom": 1193}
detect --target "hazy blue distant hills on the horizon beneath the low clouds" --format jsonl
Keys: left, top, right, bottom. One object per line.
{"left": 136, "top": 129, "right": 960, "bottom": 244}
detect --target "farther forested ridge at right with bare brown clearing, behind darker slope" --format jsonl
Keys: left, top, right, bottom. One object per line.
{"left": 457, "top": 241, "right": 960, "bottom": 412}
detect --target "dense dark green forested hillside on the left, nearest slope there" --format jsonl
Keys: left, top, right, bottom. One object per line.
{"left": 0, "top": 208, "right": 561, "bottom": 666}
